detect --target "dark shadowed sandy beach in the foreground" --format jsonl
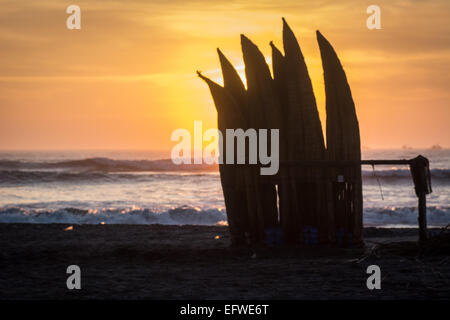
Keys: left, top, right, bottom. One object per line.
{"left": 0, "top": 224, "right": 450, "bottom": 299}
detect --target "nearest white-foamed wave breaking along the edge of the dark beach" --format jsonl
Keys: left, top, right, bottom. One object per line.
{"left": 0, "top": 206, "right": 450, "bottom": 227}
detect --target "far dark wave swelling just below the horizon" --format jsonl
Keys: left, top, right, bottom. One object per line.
{"left": 0, "top": 158, "right": 450, "bottom": 184}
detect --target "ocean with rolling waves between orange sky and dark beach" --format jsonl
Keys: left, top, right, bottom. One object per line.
{"left": 0, "top": 149, "right": 450, "bottom": 227}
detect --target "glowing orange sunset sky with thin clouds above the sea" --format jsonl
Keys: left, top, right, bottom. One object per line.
{"left": 0, "top": 0, "right": 450, "bottom": 150}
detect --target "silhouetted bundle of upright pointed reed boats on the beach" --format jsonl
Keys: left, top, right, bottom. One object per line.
{"left": 198, "top": 18, "right": 428, "bottom": 246}
